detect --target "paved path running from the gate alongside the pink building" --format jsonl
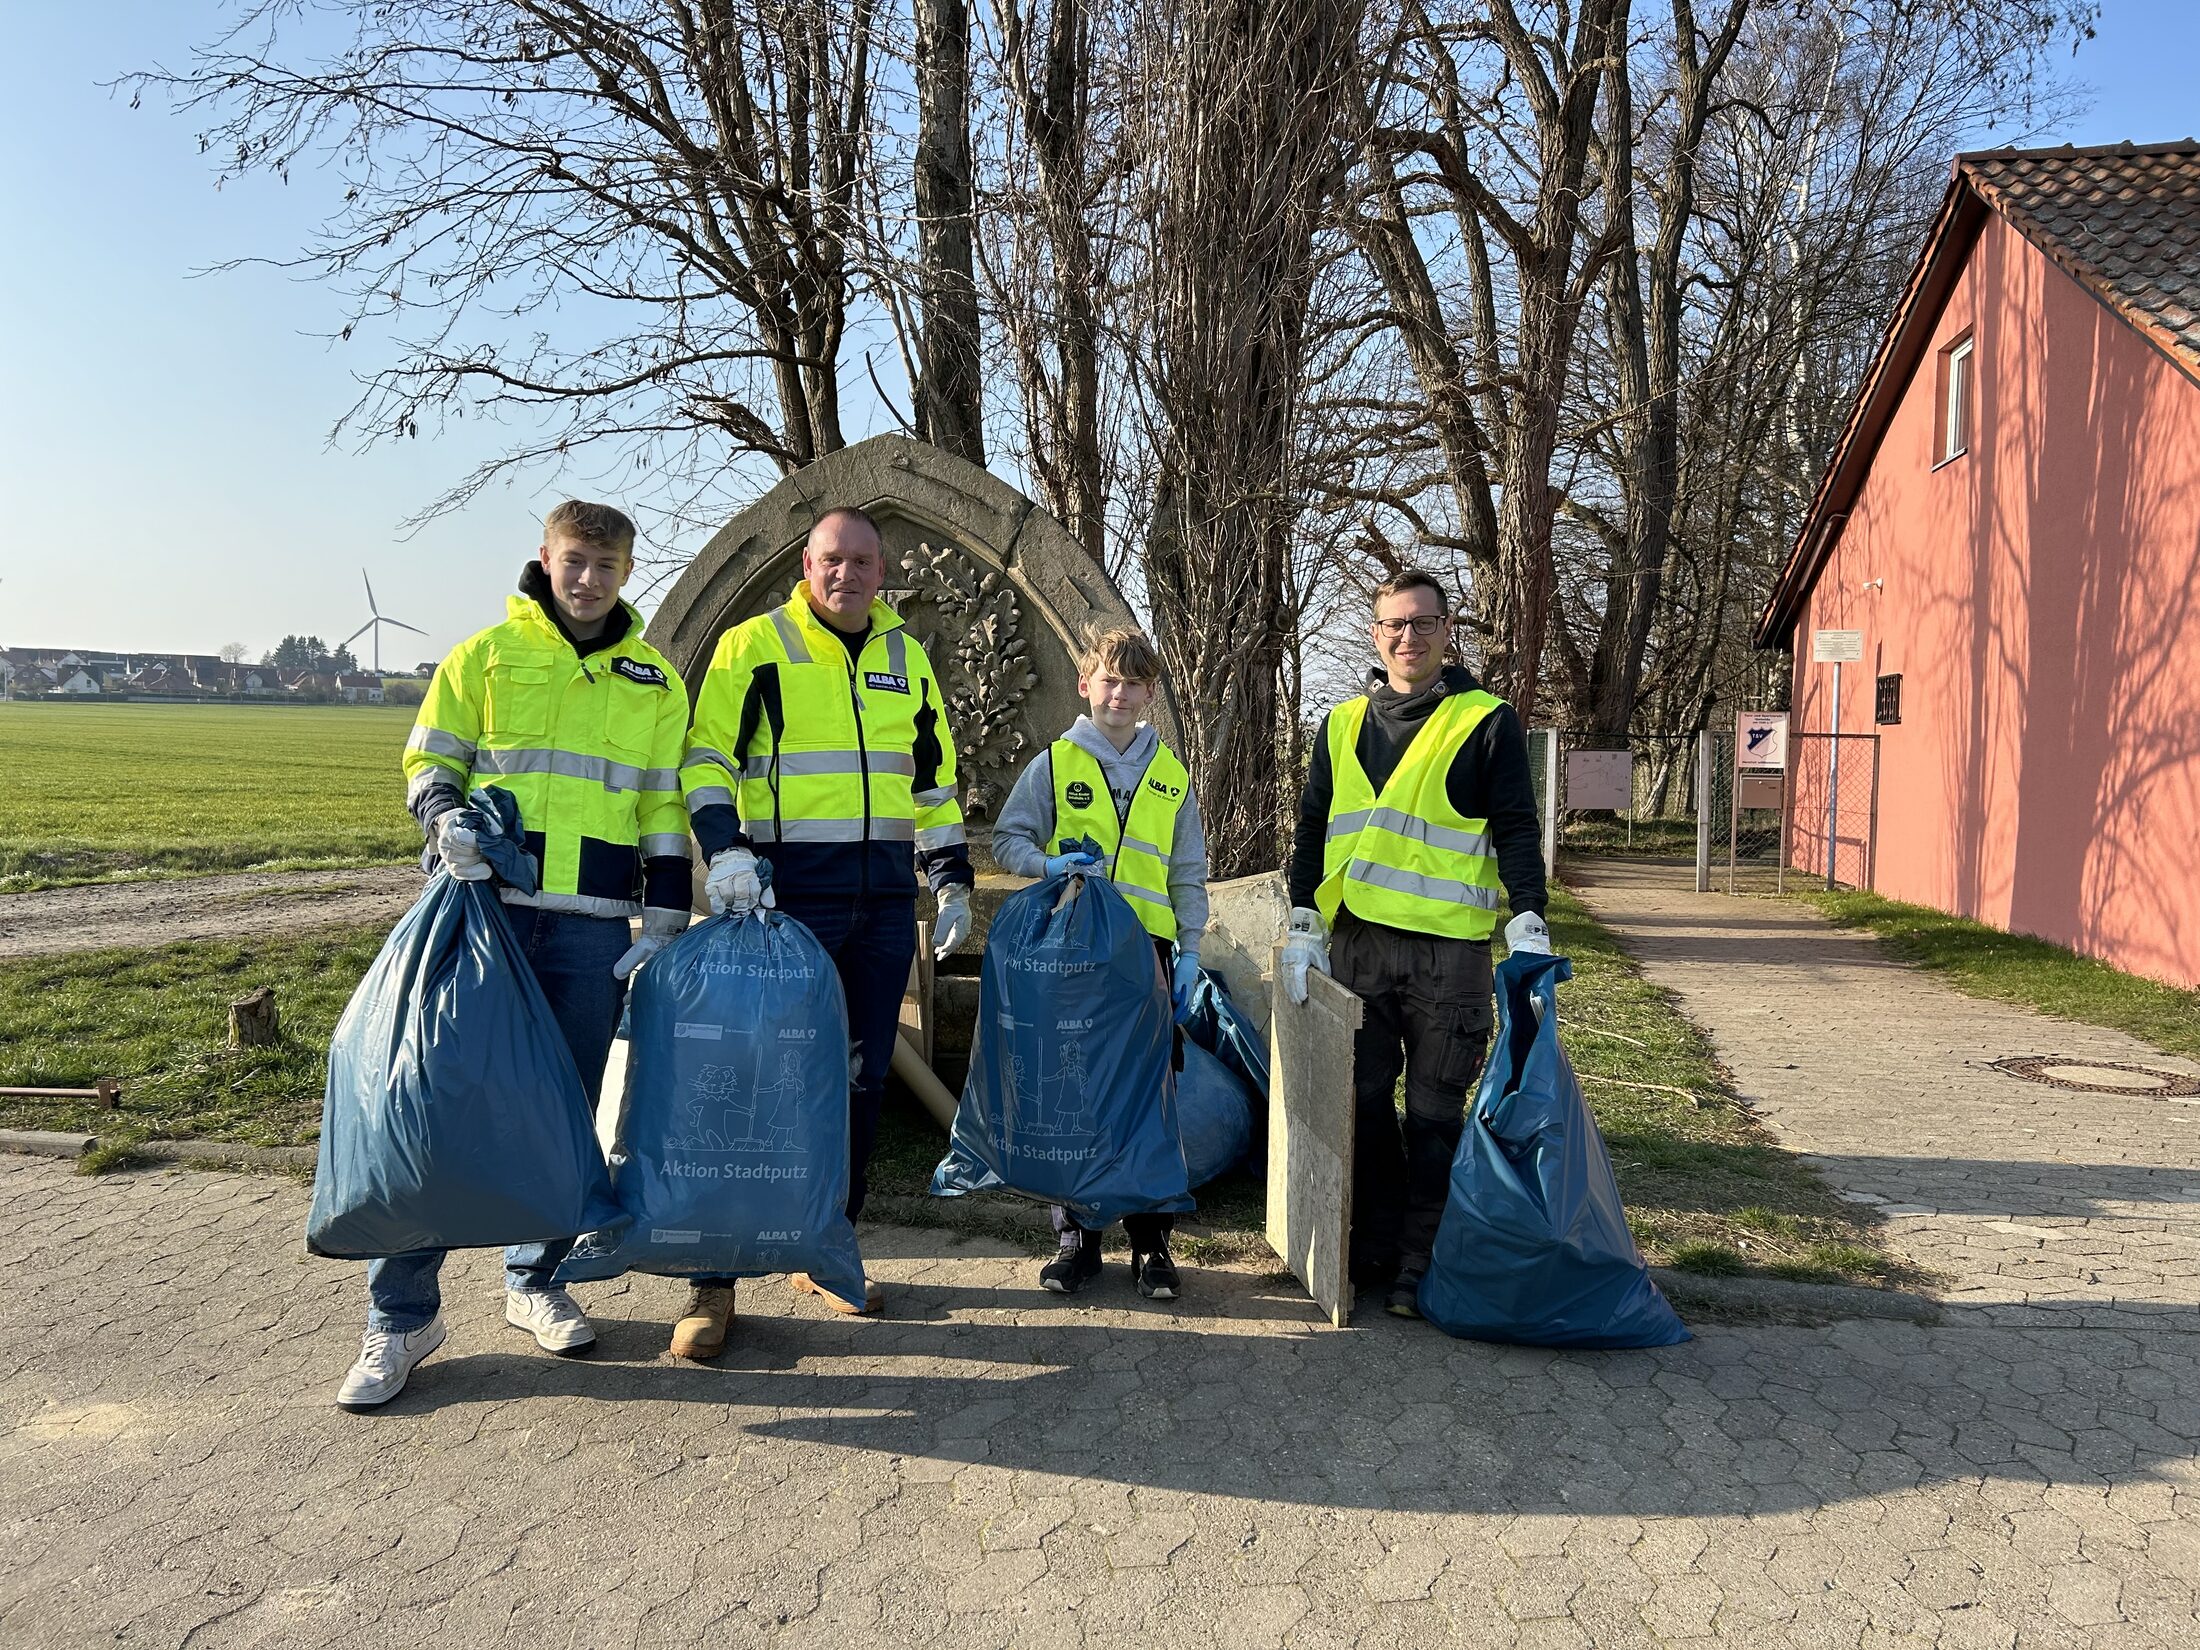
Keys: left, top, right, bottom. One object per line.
{"left": 1573, "top": 860, "right": 2200, "bottom": 1328}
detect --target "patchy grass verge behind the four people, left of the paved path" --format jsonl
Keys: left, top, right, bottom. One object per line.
{"left": 0, "top": 893, "right": 1910, "bottom": 1283}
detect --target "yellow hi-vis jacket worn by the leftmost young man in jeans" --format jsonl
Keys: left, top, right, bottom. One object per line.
{"left": 405, "top": 596, "right": 689, "bottom": 917}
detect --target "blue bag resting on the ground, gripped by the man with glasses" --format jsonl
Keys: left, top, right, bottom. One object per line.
{"left": 1419, "top": 953, "right": 1687, "bottom": 1346}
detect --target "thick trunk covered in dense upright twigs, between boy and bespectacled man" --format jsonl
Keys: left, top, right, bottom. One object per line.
{"left": 1131, "top": 0, "right": 1360, "bottom": 876}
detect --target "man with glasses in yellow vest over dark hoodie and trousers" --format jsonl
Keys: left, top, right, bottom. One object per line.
{"left": 1283, "top": 572, "right": 1551, "bottom": 1318}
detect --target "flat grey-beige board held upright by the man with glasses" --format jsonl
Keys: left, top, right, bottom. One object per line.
{"left": 1267, "top": 948, "right": 1360, "bottom": 1329}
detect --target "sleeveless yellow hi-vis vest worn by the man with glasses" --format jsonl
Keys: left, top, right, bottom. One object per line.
{"left": 1313, "top": 689, "right": 1505, "bottom": 939}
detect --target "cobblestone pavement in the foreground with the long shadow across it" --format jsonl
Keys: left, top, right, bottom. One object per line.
{"left": 0, "top": 1157, "right": 2200, "bottom": 1650}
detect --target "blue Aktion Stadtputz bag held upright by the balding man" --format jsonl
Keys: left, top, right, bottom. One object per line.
{"left": 557, "top": 909, "right": 862, "bottom": 1300}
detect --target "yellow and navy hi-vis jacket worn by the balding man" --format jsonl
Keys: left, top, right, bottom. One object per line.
{"left": 680, "top": 583, "right": 968, "bottom": 893}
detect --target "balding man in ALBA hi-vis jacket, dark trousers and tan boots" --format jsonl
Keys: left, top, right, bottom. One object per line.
{"left": 671, "top": 506, "right": 977, "bottom": 1357}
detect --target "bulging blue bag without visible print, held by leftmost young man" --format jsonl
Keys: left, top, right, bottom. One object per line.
{"left": 306, "top": 790, "right": 618, "bottom": 1261}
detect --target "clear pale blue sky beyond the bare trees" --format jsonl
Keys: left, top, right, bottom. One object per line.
{"left": 0, "top": 0, "right": 2200, "bottom": 664}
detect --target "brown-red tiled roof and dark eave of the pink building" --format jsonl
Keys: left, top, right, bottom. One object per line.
{"left": 1756, "top": 139, "right": 2200, "bottom": 647}
